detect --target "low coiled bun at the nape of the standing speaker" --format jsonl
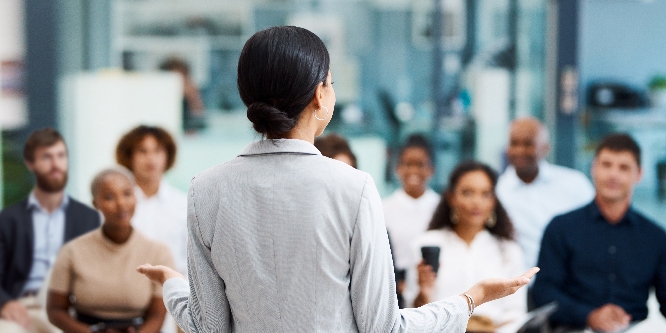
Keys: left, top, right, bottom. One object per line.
{"left": 247, "top": 102, "right": 296, "bottom": 136}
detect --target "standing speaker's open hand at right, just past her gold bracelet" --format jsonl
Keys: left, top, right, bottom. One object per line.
{"left": 466, "top": 267, "right": 539, "bottom": 307}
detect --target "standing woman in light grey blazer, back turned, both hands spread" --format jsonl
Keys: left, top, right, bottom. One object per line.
{"left": 138, "top": 27, "right": 536, "bottom": 333}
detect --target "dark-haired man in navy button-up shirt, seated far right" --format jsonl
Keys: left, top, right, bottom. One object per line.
{"left": 533, "top": 134, "right": 666, "bottom": 332}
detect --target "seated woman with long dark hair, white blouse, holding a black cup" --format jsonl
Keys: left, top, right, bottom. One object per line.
{"left": 405, "top": 161, "right": 527, "bottom": 331}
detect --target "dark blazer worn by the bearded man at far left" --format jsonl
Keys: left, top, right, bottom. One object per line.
{"left": 0, "top": 197, "right": 101, "bottom": 308}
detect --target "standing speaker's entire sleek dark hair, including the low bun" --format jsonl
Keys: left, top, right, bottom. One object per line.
{"left": 238, "top": 27, "right": 330, "bottom": 138}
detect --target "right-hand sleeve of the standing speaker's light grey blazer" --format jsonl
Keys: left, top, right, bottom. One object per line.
{"left": 350, "top": 176, "right": 468, "bottom": 332}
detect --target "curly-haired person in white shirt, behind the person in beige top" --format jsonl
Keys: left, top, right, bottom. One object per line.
{"left": 116, "top": 126, "right": 187, "bottom": 276}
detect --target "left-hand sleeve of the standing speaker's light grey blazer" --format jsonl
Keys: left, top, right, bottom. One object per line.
{"left": 163, "top": 180, "right": 232, "bottom": 333}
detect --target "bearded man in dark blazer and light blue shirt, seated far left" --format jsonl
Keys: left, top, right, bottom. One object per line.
{"left": 0, "top": 128, "right": 100, "bottom": 333}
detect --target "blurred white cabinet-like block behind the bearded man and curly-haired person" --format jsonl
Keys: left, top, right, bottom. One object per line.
{"left": 59, "top": 72, "right": 183, "bottom": 203}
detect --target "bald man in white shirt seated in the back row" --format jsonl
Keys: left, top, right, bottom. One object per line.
{"left": 496, "top": 117, "right": 594, "bottom": 267}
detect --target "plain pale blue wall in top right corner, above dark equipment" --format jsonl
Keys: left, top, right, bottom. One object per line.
{"left": 579, "top": 0, "right": 666, "bottom": 89}
